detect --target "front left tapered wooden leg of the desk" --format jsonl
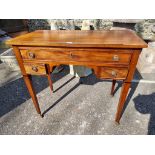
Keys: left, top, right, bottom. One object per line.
{"left": 23, "top": 75, "right": 42, "bottom": 116}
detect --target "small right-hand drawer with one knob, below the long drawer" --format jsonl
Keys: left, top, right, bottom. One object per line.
{"left": 98, "top": 67, "right": 128, "bottom": 79}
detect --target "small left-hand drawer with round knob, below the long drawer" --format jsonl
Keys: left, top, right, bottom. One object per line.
{"left": 24, "top": 64, "right": 46, "bottom": 75}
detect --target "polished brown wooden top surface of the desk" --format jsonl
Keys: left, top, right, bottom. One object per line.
{"left": 6, "top": 30, "right": 147, "bottom": 48}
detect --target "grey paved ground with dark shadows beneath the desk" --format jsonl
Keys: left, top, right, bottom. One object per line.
{"left": 0, "top": 64, "right": 155, "bottom": 134}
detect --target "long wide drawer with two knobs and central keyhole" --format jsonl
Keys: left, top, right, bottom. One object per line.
{"left": 21, "top": 48, "right": 132, "bottom": 64}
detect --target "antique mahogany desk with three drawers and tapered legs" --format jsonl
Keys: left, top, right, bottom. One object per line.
{"left": 7, "top": 30, "right": 147, "bottom": 122}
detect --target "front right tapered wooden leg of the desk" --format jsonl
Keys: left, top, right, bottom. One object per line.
{"left": 115, "top": 82, "right": 131, "bottom": 123}
